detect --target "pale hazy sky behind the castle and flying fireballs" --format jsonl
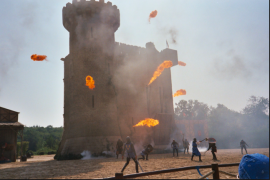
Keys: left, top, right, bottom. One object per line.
{"left": 0, "top": 0, "right": 269, "bottom": 126}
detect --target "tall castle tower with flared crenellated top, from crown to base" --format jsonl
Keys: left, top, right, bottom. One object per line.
{"left": 58, "top": 0, "right": 121, "bottom": 154}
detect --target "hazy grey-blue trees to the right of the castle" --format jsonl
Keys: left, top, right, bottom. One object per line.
{"left": 175, "top": 96, "right": 269, "bottom": 149}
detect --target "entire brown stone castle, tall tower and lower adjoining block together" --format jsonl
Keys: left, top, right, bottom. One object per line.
{"left": 58, "top": 0, "right": 178, "bottom": 154}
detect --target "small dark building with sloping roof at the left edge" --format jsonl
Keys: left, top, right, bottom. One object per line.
{"left": 0, "top": 107, "right": 24, "bottom": 162}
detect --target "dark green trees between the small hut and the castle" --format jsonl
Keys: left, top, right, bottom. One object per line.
{"left": 17, "top": 125, "right": 63, "bottom": 154}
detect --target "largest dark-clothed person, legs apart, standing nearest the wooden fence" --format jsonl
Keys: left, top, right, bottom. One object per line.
{"left": 121, "top": 136, "right": 139, "bottom": 173}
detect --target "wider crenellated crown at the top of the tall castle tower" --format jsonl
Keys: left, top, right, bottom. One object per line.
{"left": 62, "top": 0, "right": 120, "bottom": 32}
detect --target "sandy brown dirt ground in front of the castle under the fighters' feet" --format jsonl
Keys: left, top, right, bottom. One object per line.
{"left": 0, "top": 148, "right": 269, "bottom": 179}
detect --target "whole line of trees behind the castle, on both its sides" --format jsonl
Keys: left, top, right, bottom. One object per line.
{"left": 18, "top": 96, "right": 269, "bottom": 154}
